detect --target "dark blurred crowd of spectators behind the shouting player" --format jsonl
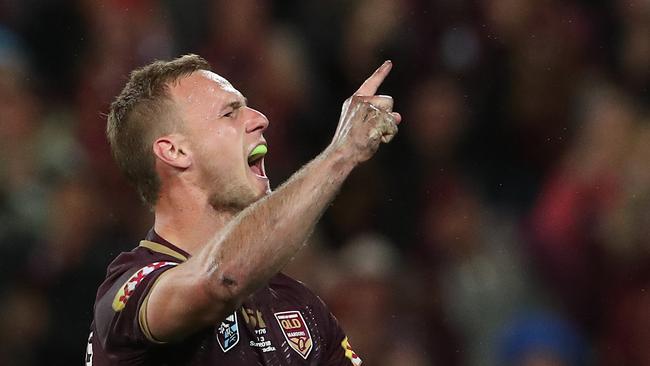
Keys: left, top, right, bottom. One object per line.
{"left": 0, "top": 0, "right": 650, "bottom": 366}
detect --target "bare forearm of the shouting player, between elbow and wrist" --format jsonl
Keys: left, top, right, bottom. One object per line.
{"left": 197, "top": 144, "right": 355, "bottom": 299}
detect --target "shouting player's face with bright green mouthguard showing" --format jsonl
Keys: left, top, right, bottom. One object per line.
{"left": 170, "top": 70, "right": 271, "bottom": 210}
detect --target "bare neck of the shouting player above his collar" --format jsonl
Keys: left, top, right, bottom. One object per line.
{"left": 154, "top": 192, "right": 236, "bottom": 255}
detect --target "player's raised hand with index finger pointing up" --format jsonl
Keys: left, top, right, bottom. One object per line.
{"left": 330, "top": 61, "right": 402, "bottom": 163}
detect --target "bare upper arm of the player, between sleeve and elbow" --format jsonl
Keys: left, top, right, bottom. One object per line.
{"left": 140, "top": 263, "right": 232, "bottom": 343}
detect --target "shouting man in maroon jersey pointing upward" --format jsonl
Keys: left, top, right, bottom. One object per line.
{"left": 86, "top": 55, "right": 401, "bottom": 366}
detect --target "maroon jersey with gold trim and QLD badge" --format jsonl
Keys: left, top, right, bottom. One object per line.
{"left": 86, "top": 230, "right": 361, "bottom": 366}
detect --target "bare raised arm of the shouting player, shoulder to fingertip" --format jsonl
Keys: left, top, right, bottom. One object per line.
{"left": 146, "top": 61, "right": 401, "bottom": 341}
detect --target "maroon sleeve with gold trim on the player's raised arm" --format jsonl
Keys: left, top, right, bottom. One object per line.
{"left": 95, "top": 261, "right": 178, "bottom": 357}
